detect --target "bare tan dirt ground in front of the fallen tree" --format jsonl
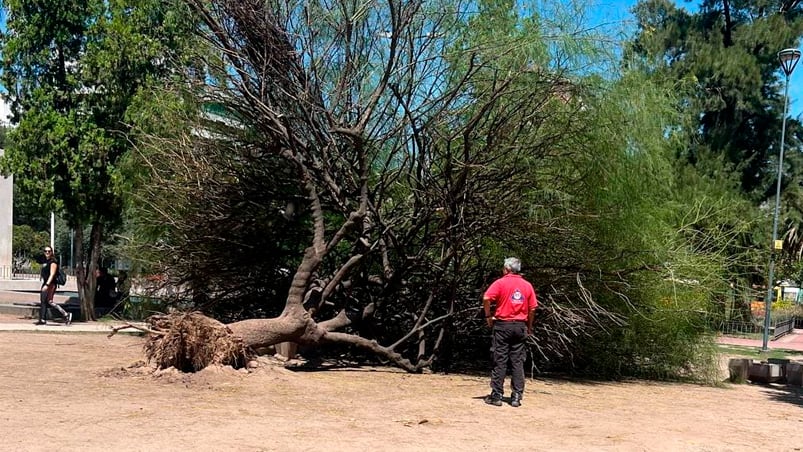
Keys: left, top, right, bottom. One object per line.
{"left": 0, "top": 331, "right": 803, "bottom": 451}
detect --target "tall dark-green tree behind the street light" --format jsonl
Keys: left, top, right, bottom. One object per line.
{"left": 629, "top": 0, "right": 803, "bottom": 287}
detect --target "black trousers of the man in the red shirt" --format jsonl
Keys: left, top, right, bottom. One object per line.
{"left": 491, "top": 320, "right": 527, "bottom": 396}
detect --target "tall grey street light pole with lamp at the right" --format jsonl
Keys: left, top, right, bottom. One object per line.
{"left": 761, "top": 49, "right": 800, "bottom": 352}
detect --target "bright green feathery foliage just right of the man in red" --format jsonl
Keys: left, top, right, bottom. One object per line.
{"left": 450, "top": 27, "right": 755, "bottom": 381}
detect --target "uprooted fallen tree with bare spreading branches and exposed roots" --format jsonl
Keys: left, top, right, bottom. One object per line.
{"left": 122, "top": 0, "right": 720, "bottom": 378}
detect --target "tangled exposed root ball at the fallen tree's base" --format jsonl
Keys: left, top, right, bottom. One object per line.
{"left": 145, "top": 312, "right": 254, "bottom": 372}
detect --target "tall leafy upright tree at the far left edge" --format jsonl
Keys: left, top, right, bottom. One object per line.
{"left": 2, "top": 0, "right": 195, "bottom": 319}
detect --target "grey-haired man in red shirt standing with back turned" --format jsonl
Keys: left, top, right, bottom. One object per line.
{"left": 482, "top": 257, "right": 538, "bottom": 407}
